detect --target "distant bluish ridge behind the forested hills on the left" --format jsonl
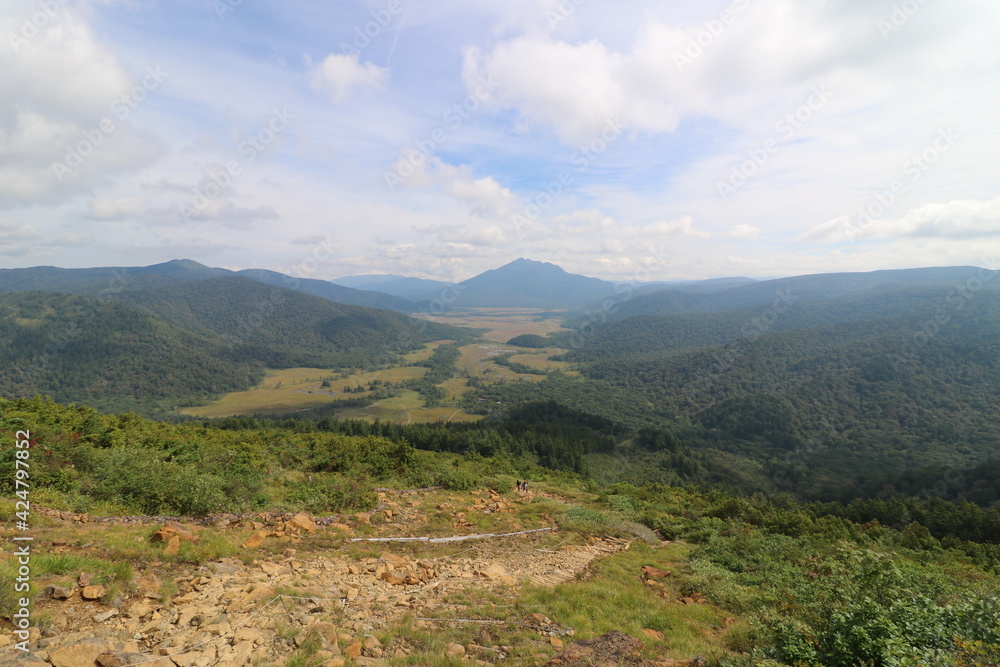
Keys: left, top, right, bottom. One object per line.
{"left": 0, "top": 259, "right": 417, "bottom": 312}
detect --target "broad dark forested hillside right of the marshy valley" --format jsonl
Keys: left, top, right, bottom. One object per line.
{"left": 468, "top": 278, "right": 1000, "bottom": 505}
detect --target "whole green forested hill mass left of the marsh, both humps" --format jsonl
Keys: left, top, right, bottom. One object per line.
{"left": 0, "top": 275, "right": 467, "bottom": 414}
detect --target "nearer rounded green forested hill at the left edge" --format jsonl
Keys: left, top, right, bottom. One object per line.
{"left": 0, "top": 292, "right": 263, "bottom": 413}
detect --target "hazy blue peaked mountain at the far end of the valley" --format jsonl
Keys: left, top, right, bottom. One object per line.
{"left": 448, "top": 258, "right": 615, "bottom": 309}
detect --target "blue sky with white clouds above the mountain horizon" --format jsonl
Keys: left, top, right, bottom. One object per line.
{"left": 0, "top": 0, "right": 1000, "bottom": 281}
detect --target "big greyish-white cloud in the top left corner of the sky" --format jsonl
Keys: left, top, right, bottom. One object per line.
{"left": 0, "top": 0, "right": 164, "bottom": 208}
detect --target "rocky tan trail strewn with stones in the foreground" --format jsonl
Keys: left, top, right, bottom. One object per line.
{"left": 0, "top": 492, "right": 700, "bottom": 667}
